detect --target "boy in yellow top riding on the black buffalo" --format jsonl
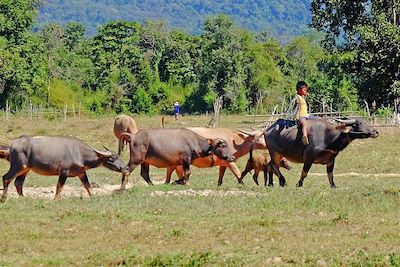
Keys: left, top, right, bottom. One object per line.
{"left": 287, "top": 81, "right": 311, "bottom": 145}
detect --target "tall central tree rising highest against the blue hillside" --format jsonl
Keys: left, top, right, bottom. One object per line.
{"left": 199, "top": 15, "right": 250, "bottom": 111}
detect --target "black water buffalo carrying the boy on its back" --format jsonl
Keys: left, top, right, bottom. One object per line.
{"left": 264, "top": 119, "right": 379, "bottom": 188}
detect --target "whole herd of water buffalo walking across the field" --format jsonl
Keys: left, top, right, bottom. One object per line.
{"left": 0, "top": 115, "right": 378, "bottom": 202}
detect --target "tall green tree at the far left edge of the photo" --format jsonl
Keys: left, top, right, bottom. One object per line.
{"left": 0, "top": 0, "right": 45, "bottom": 106}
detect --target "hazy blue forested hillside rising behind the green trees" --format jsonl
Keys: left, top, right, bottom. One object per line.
{"left": 38, "top": 0, "right": 311, "bottom": 40}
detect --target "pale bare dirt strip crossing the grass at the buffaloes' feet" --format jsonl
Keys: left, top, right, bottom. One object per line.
{"left": 0, "top": 172, "right": 400, "bottom": 199}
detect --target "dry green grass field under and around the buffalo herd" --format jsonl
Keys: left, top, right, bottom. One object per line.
{"left": 0, "top": 116, "right": 400, "bottom": 266}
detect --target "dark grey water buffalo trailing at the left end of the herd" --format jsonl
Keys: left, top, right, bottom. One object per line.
{"left": 0, "top": 135, "right": 128, "bottom": 201}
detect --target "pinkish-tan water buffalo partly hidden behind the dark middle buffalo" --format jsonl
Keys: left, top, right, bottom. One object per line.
{"left": 165, "top": 127, "right": 267, "bottom": 185}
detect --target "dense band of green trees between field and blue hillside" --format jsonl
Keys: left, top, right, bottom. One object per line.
{"left": 0, "top": 0, "right": 400, "bottom": 114}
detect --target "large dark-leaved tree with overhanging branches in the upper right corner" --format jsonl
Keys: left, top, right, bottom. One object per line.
{"left": 312, "top": 0, "right": 400, "bottom": 105}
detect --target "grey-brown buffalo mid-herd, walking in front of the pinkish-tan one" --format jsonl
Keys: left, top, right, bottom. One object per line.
{"left": 120, "top": 128, "right": 235, "bottom": 189}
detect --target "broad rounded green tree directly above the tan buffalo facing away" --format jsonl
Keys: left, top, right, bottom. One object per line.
{"left": 91, "top": 20, "right": 142, "bottom": 109}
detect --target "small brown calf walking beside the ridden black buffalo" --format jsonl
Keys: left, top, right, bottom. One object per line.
{"left": 240, "top": 149, "right": 291, "bottom": 186}
